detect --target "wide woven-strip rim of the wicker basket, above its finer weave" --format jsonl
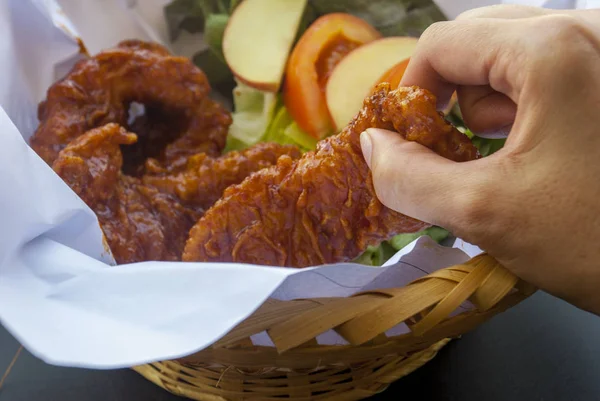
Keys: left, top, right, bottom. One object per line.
{"left": 177, "top": 253, "right": 536, "bottom": 365}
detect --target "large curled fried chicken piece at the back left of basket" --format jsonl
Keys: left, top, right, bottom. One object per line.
{"left": 31, "top": 41, "right": 231, "bottom": 164}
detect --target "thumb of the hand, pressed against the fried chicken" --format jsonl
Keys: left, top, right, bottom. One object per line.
{"left": 360, "top": 128, "right": 489, "bottom": 236}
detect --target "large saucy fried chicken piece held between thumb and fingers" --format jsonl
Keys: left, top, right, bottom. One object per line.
{"left": 183, "top": 84, "right": 479, "bottom": 267}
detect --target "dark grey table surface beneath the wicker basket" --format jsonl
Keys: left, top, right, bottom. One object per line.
{"left": 0, "top": 293, "right": 600, "bottom": 401}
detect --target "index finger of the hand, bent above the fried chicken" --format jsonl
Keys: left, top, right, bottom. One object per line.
{"left": 400, "top": 18, "right": 528, "bottom": 107}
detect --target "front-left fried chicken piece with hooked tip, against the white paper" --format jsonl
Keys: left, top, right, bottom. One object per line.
{"left": 52, "top": 124, "right": 199, "bottom": 264}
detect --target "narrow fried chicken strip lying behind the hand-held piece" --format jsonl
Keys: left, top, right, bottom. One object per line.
{"left": 143, "top": 143, "right": 301, "bottom": 211}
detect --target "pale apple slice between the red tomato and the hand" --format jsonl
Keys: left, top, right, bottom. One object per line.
{"left": 325, "top": 36, "right": 417, "bottom": 131}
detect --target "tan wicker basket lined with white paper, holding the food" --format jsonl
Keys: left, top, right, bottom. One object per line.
{"left": 134, "top": 254, "right": 535, "bottom": 401}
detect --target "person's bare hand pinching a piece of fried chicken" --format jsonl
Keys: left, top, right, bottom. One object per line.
{"left": 361, "top": 6, "right": 600, "bottom": 314}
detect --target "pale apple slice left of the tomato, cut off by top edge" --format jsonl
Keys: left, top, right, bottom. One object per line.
{"left": 223, "top": 0, "right": 307, "bottom": 92}
